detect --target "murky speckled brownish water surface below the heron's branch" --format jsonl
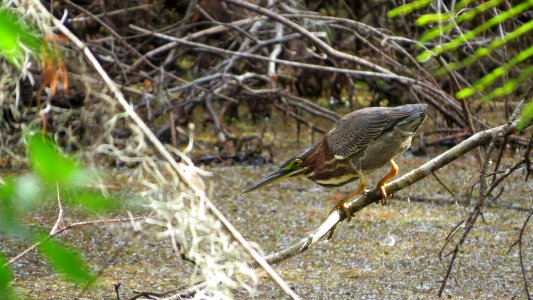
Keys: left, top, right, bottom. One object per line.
{"left": 0, "top": 151, "right": 533, "bottom": 299}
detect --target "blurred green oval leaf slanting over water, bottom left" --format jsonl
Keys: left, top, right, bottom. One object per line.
{"left": 39, "top": 239, "right": 95, "bottom": 284}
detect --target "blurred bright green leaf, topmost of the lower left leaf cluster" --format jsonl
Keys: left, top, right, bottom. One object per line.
{"left": 27, "top": 133, "right": 78, "bottom": 185}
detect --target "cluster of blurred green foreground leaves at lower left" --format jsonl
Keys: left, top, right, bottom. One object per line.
{"left": 0, "top": 132, "right": 117, "bottom": 299}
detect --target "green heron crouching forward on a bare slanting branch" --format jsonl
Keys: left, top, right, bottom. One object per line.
{"left": 242, "top": 104, "right": 427, "bottom": 217}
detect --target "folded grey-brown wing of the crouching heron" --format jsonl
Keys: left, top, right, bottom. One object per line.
{"left": 326, "top": 104, "right": 427, "bottom": 159}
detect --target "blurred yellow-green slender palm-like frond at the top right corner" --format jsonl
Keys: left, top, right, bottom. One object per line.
{"left": 389, "top": 0, "right": 533, "bottom": 101}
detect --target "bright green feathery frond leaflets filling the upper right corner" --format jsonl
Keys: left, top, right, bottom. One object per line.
{"left": 388, "top": 0, "right": 533, "bottom": 123}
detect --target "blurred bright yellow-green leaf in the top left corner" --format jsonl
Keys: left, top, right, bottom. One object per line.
{"left": 0, "top": 8, "right": 42, "bottom": 68}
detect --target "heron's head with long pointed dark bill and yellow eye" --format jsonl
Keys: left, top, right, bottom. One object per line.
{"left": 241, "top": 146, "right": 314, "bottom": 194}
